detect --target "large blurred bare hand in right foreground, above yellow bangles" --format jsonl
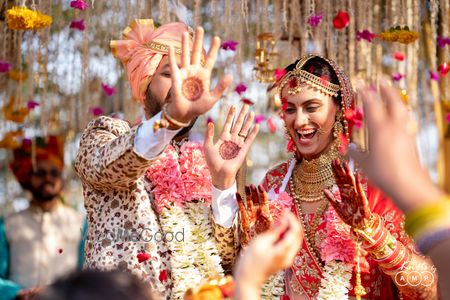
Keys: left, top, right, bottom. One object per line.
{"left": 349, "top": 81, "right": 443, "bottom": 211}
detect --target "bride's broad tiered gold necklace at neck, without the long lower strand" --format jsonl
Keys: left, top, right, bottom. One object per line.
{"left": 293, "top": 139, "right": 342, "bottom": 202}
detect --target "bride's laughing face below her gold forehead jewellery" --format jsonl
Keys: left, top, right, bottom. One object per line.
{"left": 281, "top": 84, "right": 338, "bottom": 159}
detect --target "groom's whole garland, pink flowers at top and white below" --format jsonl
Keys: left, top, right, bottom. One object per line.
{"left": 147, "top": 143, "right": 223, "bottom": 299}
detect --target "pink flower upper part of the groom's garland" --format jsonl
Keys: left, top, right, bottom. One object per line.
{"left": 147, "top": 142, "right": 211, "bottom": 213}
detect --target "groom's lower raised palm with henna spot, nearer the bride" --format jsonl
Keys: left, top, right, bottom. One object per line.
{"left": 204, "top": 104, "right": 259, "bottom": 190}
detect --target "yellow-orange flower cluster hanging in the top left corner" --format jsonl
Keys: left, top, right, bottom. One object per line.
{"left": 6, "top": 6, "right": 53, "bottom": 30}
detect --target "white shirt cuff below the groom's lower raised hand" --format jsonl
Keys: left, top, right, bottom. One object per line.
{"left": 211, "top": 182, "right": 238, "bottom": 228}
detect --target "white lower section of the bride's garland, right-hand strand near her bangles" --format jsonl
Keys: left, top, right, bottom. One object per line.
{"left": 317, "top": 260, "right": 352, "bottom": 300}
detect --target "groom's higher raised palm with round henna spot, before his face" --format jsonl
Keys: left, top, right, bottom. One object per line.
{"left": 167, "top": 27, "right": 232, "bottom": 123}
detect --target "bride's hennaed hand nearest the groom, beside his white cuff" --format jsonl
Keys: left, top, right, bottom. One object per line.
{"left": 236, "top": 185, "right": 273, "bottom": 246}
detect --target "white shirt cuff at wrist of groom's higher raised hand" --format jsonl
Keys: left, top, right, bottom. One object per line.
{"left": 134, "top": 112, "right": 181, "bottom": 159}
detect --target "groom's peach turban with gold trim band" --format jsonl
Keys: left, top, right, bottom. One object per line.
{"left": 110, "top": 19, "right": 192, "bottom": 103}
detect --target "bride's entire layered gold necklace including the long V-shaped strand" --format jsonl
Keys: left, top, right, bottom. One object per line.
{"left": 290, "top": 139, "right": 342, "bottom": 266}
